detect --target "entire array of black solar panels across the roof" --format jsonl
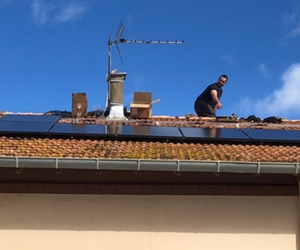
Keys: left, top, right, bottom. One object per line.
{"left": 0, "top": 115, "right": 300, "bottom": 143}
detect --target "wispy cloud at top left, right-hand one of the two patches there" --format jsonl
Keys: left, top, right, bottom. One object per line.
{"left": 55, "top": 2, "right": 87, "bottom": 22}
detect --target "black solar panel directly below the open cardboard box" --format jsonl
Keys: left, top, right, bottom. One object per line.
{"left": 118, "top": 126, "right": 183, "bottom": 139}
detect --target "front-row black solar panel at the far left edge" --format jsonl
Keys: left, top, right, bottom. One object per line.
{"left": 0, "top": 122, "right": 53, "bottom": 134}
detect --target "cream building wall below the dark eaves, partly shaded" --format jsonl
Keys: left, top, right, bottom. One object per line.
{"left": 0, "top": 194, "right": 299, "bottom": 250}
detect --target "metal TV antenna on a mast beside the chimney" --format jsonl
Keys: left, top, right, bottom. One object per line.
{"left": 106, "top": 21, "right": 184, "bottom": 118}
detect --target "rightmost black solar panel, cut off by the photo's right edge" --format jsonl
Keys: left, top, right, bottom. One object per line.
{"left": 242, "top": 129, "right": 300, "bottom": 142}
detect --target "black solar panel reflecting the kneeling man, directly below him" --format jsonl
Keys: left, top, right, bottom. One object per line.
{"left": 180, "top": 128, "right": 249, "bottom": 140}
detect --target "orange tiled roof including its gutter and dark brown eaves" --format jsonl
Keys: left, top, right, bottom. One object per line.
{"left": 0, "top": 116, "right": 300, "bottom": 195}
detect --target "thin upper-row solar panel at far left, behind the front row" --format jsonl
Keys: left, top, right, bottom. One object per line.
{"left": 0, "top": 115, "right": 60, "bottom": 123}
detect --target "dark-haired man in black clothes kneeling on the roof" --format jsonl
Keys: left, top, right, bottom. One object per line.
{"left": 194, "top": 75, "right": 228, "bottom": 117}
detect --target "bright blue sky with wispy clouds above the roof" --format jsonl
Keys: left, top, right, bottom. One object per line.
{"left": 0, "top": 0, "right": 300, "bottom": 119}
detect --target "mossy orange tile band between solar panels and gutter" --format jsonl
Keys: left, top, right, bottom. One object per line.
{"left": 0, "top": 136, "right": 300, "bottom": 162}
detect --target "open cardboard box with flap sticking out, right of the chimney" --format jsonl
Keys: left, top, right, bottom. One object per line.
{"left": 130, "top": 92, "right": 160, "bottom": 118}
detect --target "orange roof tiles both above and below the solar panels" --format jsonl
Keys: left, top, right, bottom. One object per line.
{"left": 0, "top": 117, "right": 300, "bottom": 163}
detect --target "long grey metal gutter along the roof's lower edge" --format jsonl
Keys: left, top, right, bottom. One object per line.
{"left": 0, "top": 157, "right": 299, "bottom": 175}
